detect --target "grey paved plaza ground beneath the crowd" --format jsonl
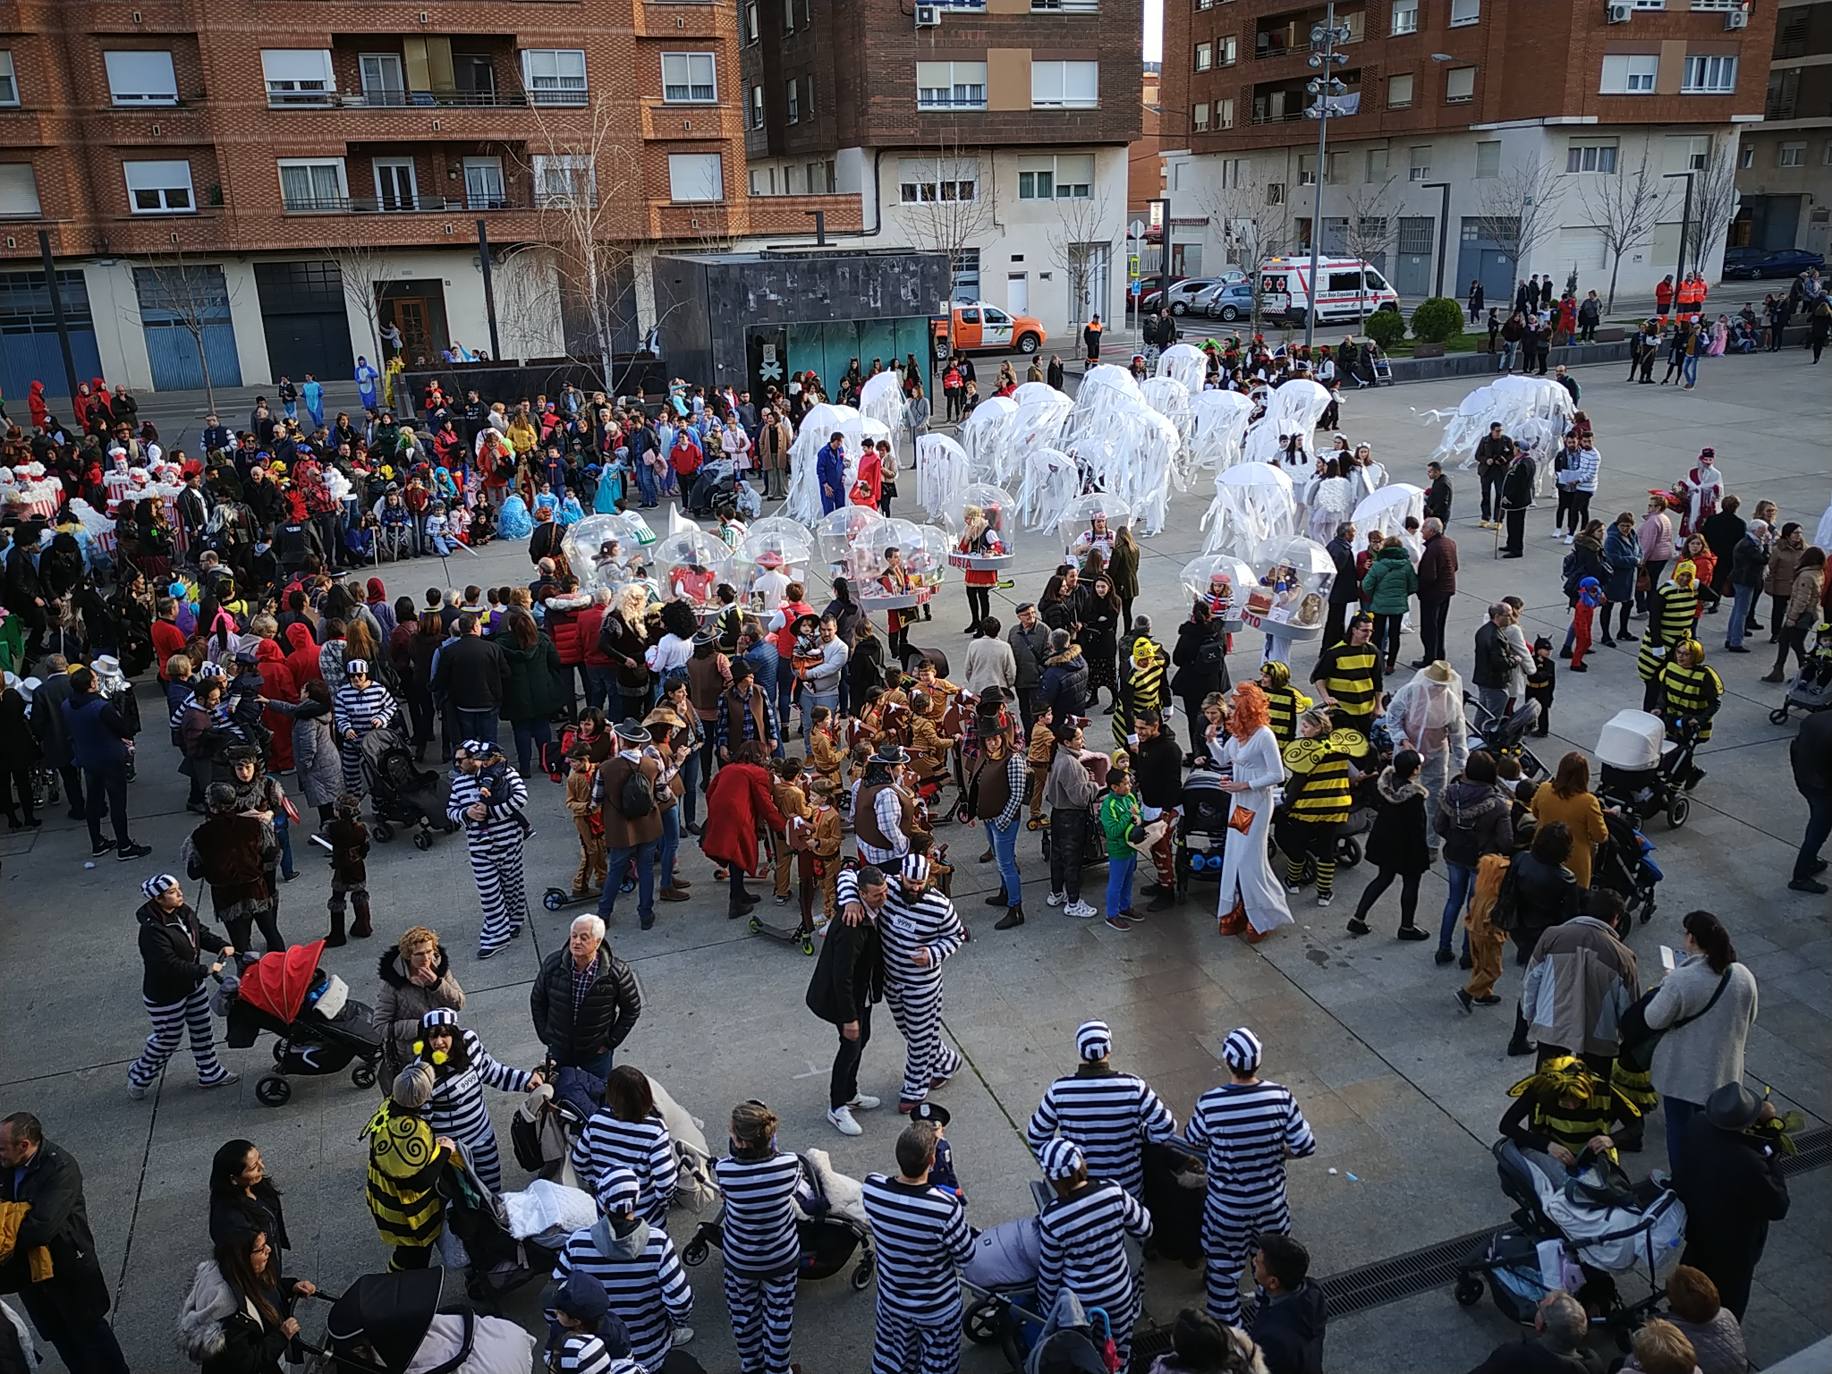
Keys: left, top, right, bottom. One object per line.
{"left": 0, "top": 350, "right": 1832, "bottom": 1374}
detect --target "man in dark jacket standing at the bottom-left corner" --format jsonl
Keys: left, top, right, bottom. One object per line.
{"left": 0, "top": 1112, "right": 126, "bottom": 1374}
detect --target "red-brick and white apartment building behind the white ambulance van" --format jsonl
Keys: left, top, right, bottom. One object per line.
{"left": 1163, "top": 0, "right": 1775, "bottom": 302}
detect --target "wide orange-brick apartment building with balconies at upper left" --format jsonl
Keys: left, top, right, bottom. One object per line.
{"left": 0, "top": 0, "right": 859, "bottom": 396}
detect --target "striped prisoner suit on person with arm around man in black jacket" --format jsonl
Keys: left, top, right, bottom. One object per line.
{"left": 839, "top": 872, "right": 965, "bottom": 1103}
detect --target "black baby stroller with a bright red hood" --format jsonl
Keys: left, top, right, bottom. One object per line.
{"left": 222, "top": 940, "right": 381, "bottom": 1107}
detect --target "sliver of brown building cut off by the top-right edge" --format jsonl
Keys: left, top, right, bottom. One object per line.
{"left": 1731, "top": 0, "right": 1832, "bottom": 258}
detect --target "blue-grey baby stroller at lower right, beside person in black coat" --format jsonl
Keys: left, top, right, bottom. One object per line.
{"left": 1455, "top": 1140, "right": 1685, "bottom": 1350}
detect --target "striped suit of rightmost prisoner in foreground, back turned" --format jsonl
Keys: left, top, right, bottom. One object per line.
{"left": 1183, "top": 1081, "right": 1317, "bottom": 1326}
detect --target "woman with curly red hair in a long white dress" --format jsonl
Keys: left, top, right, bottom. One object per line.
{"left": 1209, "top": 682, "right": 1292, "bottom": 943}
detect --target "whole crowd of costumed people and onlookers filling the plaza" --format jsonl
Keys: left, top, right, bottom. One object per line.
{"left": 0, "top": 327, "right": 1832, "bottom": 1374}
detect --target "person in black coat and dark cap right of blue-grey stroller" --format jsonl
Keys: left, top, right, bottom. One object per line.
{"left": 1673, "top": 1083, "right": 1788, "bottom": 1321}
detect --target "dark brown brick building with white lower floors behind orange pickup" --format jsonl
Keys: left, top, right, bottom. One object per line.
{"left": 738, "top": 0, "right": 1143, "bottom": 339}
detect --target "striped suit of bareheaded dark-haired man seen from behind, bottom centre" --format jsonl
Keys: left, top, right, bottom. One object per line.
{"left": 865, "top": 1174, "right": 973, "bottom": 1374}
